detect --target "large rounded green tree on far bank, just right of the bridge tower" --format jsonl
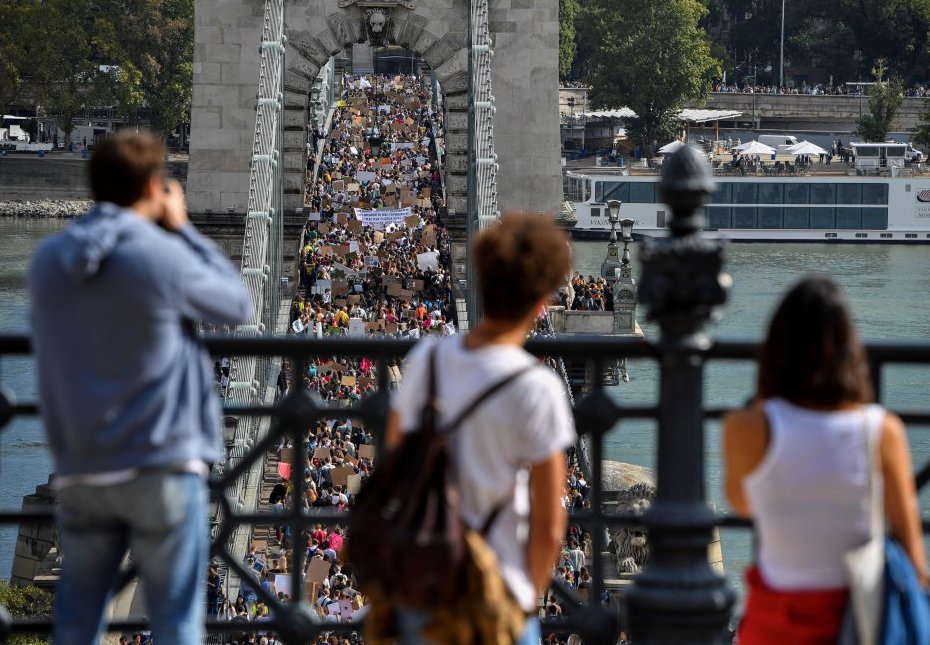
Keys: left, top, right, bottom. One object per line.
{"left": 579, "top": 0, "right": 721, "bottom": 154}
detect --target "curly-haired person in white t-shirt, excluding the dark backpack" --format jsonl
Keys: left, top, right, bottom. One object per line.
{"left": 387, "top": 215, "right": 576, "bottom": 645}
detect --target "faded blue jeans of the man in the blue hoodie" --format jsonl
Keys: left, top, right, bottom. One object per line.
{"left": 52, "top": 471, "right": 209, "bottom": 645}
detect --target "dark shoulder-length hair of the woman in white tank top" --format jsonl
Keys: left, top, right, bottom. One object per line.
{"left": 758, "top": 276, "right": 874, "bottom": 407}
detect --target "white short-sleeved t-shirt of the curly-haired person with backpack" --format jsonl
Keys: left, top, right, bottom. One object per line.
{"left": 392, "top": 335, "right": 576, "bottom": 611}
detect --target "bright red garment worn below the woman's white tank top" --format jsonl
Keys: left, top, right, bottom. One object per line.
{"left": 737, "top": 567, "right": 849, "bottom": 645}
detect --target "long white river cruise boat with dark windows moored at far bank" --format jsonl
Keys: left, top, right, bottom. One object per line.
{"left": 564, "top": 166, "right": 930, "bottom": 244}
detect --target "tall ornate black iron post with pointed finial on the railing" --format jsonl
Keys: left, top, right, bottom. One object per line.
{"left": 627, "top": 147, "right": 734, "bottom": 645}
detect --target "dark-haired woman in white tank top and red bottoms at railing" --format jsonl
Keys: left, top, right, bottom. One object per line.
{"left": 723, "top": 277, "right": 927, "bottom": 645}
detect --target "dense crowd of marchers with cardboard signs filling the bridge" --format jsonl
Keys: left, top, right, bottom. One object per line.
{"left": 214, "top": 75, "right": 612, "bottom": 645}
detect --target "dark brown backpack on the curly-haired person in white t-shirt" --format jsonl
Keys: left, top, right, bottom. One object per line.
{"left": 347, "top": 349, "right": 531, "bottom": 609}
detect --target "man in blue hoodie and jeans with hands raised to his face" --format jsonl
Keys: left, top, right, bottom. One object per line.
{"left": 29, "top": 132, "right": 252, "bottom": 645}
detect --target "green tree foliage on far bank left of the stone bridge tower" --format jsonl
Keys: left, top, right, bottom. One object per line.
{"left": 0, "top": 0, "right": 194, "bottom": 143}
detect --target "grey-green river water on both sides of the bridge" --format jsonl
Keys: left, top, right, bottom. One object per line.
{"left": 0, "top": 220, "right": 930, "bottom": 608}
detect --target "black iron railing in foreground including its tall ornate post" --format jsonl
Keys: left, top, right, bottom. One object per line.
{"left": 0, "top": 153, "right": 930, "bottom": 645}
